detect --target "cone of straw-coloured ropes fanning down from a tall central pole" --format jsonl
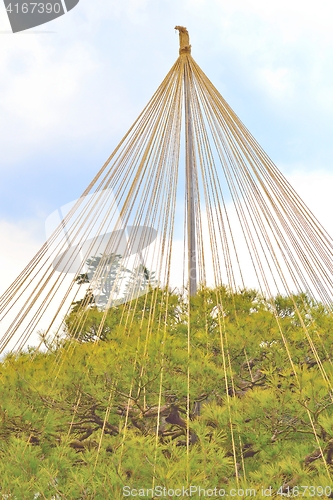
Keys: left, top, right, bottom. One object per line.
{"left": 0, "top": 26, "right": 333, "bottom": 484}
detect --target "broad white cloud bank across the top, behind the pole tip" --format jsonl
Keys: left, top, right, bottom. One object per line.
{"left": 0, "top": 0, "right": 333, "bottom": 166}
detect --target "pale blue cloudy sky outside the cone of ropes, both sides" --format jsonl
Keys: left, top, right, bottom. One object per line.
{"left": 0, "top": 0, "right": 333, "bottom": 293}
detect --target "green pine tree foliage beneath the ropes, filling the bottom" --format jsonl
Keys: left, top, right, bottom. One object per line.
{"left": 0, "top": 287, "right": 333, "bottom": 500}
